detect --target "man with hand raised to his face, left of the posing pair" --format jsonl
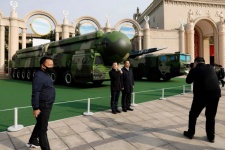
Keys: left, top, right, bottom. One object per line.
{"left": 109, "top": 62, "right": 122, "bottom": 114}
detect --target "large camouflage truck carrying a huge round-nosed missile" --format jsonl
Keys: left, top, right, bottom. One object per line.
{"left": 10, "top": 31, "right": 160, "bottom": 85}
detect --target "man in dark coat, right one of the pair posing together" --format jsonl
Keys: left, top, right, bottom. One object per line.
{"left": 122, "top": 60, "right": 134, "bottom": 112}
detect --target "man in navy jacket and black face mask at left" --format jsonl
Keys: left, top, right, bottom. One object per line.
{"left": 26, "top": 57, "right": 55, "bottom": 150}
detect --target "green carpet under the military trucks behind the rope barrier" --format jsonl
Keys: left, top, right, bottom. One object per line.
{"left": 0, "top": 78, "right": 190, "bottom": 131}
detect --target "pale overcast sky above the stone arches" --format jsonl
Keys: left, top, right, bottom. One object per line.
{"left": 0, "top": 0, "right": 153, "bottom": 26}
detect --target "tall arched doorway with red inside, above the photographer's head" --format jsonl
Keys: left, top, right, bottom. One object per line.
{"left": 194, "top": 19, "right": 218, "bottom": 64}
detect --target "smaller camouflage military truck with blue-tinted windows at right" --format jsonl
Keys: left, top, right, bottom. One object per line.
{"left": 130, "top": 52, "right": 191, "bottom": 81}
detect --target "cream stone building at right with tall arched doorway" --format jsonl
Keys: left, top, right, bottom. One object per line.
{"left": 134, "top": 0, "right": 225, "bottom": 66}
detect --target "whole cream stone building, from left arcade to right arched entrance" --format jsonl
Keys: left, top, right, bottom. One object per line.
{"left": 0, "top": 0, "right": 225, "bottom": 74}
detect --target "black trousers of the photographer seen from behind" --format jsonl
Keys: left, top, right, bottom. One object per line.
{"left": 188, "top": 97, "right": 219, "bottom": 139}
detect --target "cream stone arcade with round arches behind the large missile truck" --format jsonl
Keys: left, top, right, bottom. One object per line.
{"left": 0, "top": 1, "right": 149, "bottom": 74}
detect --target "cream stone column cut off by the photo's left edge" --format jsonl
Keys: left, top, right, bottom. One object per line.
{"left": 0, "top": 26, "right": 5, "bottom": 74}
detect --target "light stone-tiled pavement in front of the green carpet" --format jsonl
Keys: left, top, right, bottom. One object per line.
{"left": 0, "top": 88, "right": 225, "bottom": 150}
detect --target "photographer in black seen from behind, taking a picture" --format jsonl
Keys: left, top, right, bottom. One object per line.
{"left": 184, "top": 57, "right": 221, "bottom": 142}
